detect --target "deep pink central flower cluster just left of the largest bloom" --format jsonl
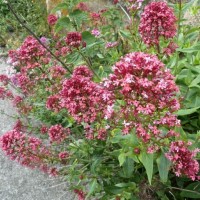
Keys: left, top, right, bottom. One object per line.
{"left": 61, "top": 66, "right": 112, "bottom": 123}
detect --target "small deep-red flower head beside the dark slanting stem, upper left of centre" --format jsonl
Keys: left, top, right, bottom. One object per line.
{"left": 65, "top": 32, "right": 82, "bottom": 48}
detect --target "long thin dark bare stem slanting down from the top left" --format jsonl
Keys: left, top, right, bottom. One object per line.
{"left": 7, "top": 0, "right": 72, "bottom": 74}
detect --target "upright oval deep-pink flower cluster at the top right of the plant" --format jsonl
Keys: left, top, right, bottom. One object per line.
{"left": 139, "top": 2, "right": 177, "bottom": 46}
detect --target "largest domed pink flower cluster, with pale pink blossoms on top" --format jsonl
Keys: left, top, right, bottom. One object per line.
{"left": 104, "top": 52, "right": 180, "bottom": 143}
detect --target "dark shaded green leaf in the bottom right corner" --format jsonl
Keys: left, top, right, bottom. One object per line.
{"left": 181, "top": 182, "right": 200, "bottom": 199}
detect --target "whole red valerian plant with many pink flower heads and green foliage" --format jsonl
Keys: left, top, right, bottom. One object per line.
{"left": 0, "top": 0, "right": 199, "bottom": 200}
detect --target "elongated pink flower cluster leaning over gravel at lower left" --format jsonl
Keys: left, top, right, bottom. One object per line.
{"left": 0, "top": 129, "right": 50, "bottom": 168}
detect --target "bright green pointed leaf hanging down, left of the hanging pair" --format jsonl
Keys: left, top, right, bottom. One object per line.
{"left": 139, "top": 152, "right": 153, "bottom": 185}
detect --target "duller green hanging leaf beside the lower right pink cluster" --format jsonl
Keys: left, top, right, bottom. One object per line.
{"left": 156, "top": 152, "right": 171, "bottom": 183}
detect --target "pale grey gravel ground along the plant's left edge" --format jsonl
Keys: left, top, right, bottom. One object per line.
{"left": 0, "top": 60, "right": 75, "bottom": 200}
